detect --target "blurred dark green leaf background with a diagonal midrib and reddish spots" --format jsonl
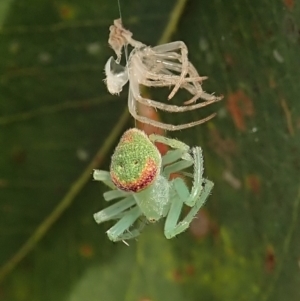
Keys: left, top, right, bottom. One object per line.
{"left": 0, "top": 0, "right": 300, "bottom": 301}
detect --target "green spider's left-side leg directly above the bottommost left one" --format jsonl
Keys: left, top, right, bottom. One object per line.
{"left": 94, "top": 196, "right": 135, "bottom": 224}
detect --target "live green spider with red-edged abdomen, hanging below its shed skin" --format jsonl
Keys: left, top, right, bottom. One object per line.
{"left": 93, "top": 128, "right": 214, "bottom": 241}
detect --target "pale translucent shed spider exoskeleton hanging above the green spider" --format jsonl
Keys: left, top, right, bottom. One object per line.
{"left": 105, "top": 19, "right": 223, "bottom": 131}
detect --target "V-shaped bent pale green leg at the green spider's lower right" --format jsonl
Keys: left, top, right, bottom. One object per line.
{"left": 164, "top": 178, "right": 214, "bottom": 239}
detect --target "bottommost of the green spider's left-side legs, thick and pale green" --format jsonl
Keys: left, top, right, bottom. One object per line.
{"left": 106, "top": 206, "right": 142, "bottom": 241}
